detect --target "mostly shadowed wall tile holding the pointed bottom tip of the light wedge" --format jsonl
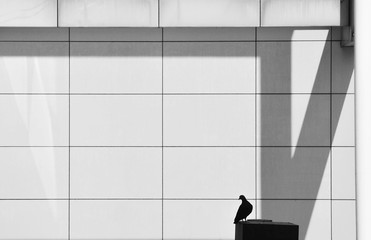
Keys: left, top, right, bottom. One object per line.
{"left": 257, "top": 147, "right": 331, "bottom": 199}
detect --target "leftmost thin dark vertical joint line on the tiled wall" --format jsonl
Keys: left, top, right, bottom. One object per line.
{"left": 68, "top": 28, "right": 71, "bottom": 240}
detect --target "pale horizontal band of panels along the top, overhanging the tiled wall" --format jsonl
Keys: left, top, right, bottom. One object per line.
{"left": 0, "top": 0, "right": 350, "bottom": 27}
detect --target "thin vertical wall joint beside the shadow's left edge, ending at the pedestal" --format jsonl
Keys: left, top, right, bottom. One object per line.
{"left": 254, "top": 28, "right": 258, "bottom": 218}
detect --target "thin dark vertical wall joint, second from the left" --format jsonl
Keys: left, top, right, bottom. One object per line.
{"left": 161, "top": 28, "right": 164, "bottom": 240}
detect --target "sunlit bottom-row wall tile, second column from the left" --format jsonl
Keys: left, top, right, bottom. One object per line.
{"left": 71, "top": 200, "right": 162, "bottom": 239}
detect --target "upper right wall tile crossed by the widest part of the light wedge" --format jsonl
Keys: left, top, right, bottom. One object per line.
{"left": 257, "top": 41, "right": 331, "bottom": 93}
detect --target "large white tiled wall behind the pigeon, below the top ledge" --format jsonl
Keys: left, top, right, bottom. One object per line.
{"left": 0, "top": 26, "right": 356, "bottom": 240}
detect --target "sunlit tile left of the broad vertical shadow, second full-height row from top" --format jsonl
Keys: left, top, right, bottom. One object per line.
{"left": 164, "top": 95, "right": 255, "bottom": 146}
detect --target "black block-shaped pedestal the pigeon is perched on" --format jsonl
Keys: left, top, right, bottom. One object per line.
{"left": 235, "top": 220, "right": 299, "bottom": 240}
